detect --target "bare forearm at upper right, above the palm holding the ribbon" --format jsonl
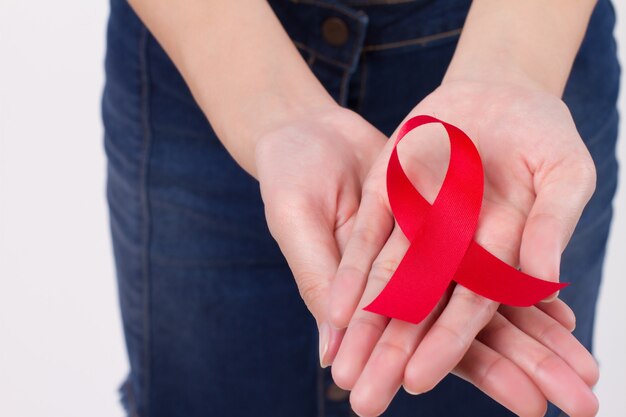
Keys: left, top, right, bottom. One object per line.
{"left": 444, "top": 0, "right": 596, "bottom": 96}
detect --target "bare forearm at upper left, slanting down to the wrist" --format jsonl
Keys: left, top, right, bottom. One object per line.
{"left": 130, "top": 0, "right": 334, "bottom": 175}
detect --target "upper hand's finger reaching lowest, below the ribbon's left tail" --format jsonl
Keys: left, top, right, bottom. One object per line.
{"left": 350, "top": 296, "right": 448, "bottom": 416}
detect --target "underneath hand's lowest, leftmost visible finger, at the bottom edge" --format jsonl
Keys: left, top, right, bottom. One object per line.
{"left": 453, "top": 340, "right": 547, "bottom": 416}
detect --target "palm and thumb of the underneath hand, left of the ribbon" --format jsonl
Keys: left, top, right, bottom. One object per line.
{"left": 255, "top": 105, "right": 391, "bottom": 366}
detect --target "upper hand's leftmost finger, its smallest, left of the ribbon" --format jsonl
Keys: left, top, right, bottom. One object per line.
{"left": 329, "top": 191, "right": 393, "bottom": 328}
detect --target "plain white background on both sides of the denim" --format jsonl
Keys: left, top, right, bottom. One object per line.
{"left": 0, "top": 0, "right": 626, "bottom": 417}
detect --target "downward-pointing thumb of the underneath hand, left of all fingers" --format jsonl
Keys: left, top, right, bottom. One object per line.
{"left": 266, "top": 199, "right": 341, "bottom": 366}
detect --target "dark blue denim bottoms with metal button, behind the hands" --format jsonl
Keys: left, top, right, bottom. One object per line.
{"left": 102, "top": 0, "right": 619, "bottom": 417}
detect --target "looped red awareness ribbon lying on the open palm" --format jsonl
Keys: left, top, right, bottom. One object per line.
{"left": 365, "top": 116, "right": 567, "bottom": 323}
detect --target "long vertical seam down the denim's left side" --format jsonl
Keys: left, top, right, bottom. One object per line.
{"left": 139, "top": 26, "right": 152, "bottom": 416}
